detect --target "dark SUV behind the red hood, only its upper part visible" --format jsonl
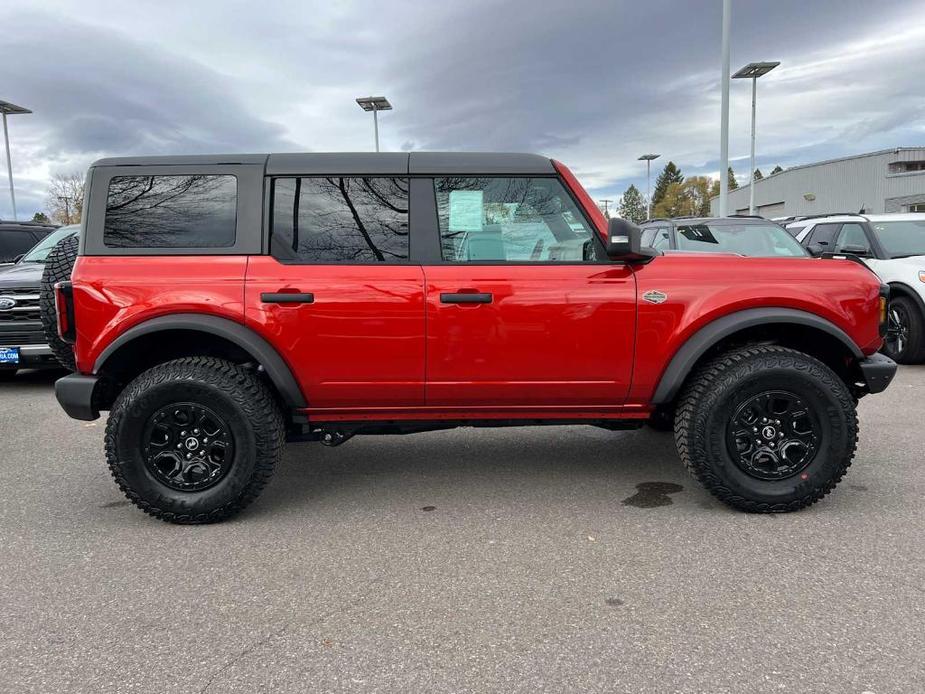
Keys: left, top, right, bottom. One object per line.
{"left": 642, "top": 216, "right": 808, "bottom": 258}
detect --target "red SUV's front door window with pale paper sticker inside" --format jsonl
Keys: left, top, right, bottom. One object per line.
{"left": 434, "top": 177, "right": 604, "bottom": 263}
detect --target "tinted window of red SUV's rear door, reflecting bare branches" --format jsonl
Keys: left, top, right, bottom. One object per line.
{"left": 270, "top": 177, "right": 408, "bottom": 263}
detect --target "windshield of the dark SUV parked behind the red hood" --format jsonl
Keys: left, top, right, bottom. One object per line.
{"left": 678, "top": 224, "right": 808, "bottom": 257}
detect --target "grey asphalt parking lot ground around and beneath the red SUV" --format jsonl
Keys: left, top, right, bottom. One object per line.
{"left": 0, "top": 367, "right": 925, "bottom": 694}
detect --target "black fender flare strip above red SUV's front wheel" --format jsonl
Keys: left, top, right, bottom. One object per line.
{"left": 652, "top": 308, "right": 864, "bottom": 405}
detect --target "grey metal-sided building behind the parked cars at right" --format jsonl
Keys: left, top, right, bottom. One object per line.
{"left": 710, "top": 147, "right": 925, "bottom": 217}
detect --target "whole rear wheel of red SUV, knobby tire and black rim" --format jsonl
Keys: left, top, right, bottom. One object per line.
{"left": 106, "top": 357, "right": 284, "bottom": 523}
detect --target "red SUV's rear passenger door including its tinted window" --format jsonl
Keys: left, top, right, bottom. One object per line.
{"left": 245, "top": 175, "right": 424, "bottom": 409}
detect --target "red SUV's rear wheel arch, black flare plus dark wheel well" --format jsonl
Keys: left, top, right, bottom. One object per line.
{"left": 93, "top": 313, "right": 307, "bottom": 409}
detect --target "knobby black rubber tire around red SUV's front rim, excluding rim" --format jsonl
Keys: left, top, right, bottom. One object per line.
{"left": 675, "top": 345, "right": 858, "bottom": 513}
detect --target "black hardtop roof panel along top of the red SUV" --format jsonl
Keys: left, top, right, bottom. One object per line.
{"left": 92, "top": 152, "right": 556, "bottom": 176}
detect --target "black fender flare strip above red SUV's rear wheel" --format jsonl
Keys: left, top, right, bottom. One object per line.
{"left": 93, "top": 313, "right": 308, "bottom": 409}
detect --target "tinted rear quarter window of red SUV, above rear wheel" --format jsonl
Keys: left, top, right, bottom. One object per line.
{"left": 103, "top": 175, "right": 238, "bottom": 248}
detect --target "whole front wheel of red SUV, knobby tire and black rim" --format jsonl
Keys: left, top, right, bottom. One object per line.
{"left": 675, "top": 346, "right": 858, "bottom": 513}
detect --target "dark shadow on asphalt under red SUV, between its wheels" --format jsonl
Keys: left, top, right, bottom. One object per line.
{"left": 247, "top": 426, "right": 700, "bottom": 515}
